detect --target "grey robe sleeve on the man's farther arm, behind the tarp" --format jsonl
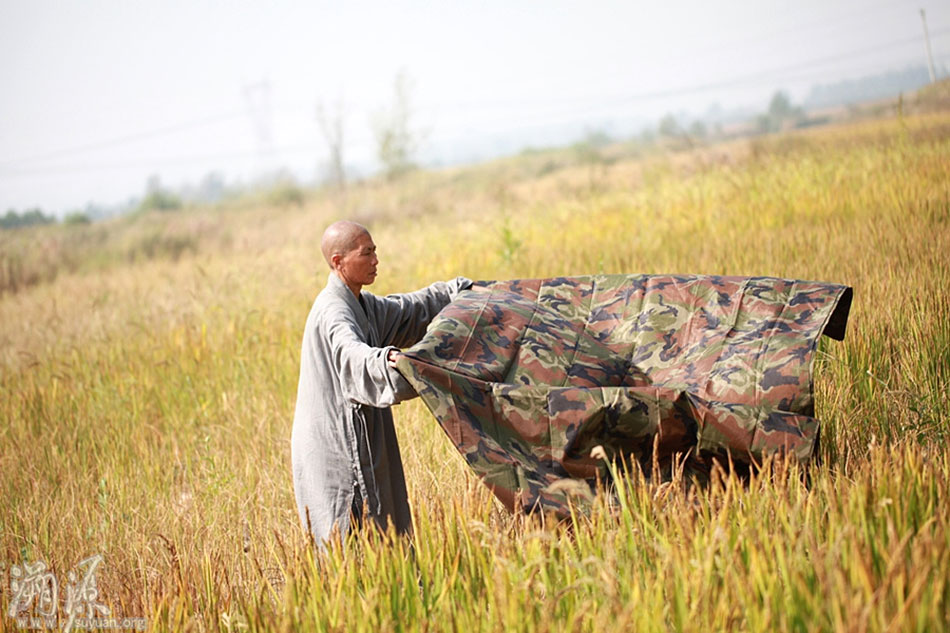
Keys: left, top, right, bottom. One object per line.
{"left": 375, "top": 277, "right": 472, "bottom": 347}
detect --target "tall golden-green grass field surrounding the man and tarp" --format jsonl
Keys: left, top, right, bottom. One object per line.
{"left": 0, "top": 114, "right": 950, "bottom": 631}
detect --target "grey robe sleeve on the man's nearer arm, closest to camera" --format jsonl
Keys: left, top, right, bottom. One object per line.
{"left": 326, "top": 310, "right": 417, "bottom": 408}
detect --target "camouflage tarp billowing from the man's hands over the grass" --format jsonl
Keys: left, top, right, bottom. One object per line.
{"left": 398, "top": 275, "right": 851, "bottom": 514}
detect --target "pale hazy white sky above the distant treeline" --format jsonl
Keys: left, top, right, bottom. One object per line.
{"left": 0, "top": 0, "right": 950, "bottom": 213}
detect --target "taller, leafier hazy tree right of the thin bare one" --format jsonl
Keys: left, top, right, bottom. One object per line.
{"left": 371, "top": 71, "right": 421, "bottom": 180}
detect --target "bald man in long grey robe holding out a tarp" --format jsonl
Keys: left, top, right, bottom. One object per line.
{"left": 291, "top": 221, "right": 472, "bottom": 548}
